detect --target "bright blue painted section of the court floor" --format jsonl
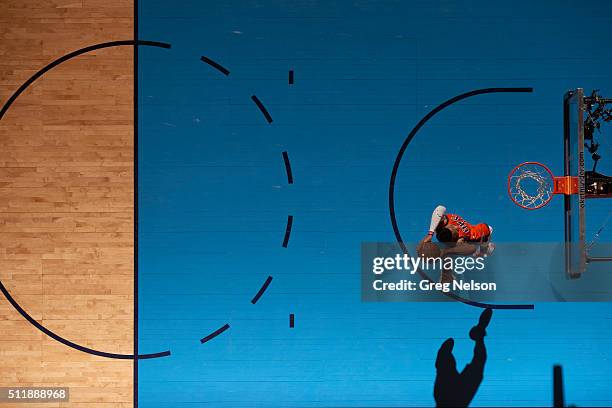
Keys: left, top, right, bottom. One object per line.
{"left": 138, "top": 0, "right": 612, "bottom": 408}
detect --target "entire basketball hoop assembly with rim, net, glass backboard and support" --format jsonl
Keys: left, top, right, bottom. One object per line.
{"left": 508, "top": 88, "right": 612, "bottom": 279}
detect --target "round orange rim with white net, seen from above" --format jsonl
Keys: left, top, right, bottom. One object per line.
{"left": 508, "top": 163, "right": 554, "bottom": 209}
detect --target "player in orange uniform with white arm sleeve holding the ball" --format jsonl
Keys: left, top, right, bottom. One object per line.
{"left": 421, "top": 205, "right": 495, "bottom": 256}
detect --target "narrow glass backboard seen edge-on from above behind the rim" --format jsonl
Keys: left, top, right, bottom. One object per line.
{"left": 563, "top": 88, "right": 587, "bottom": 279}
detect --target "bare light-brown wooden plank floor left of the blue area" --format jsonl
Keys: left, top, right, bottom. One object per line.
{"left": 0, "top": 0, "right": 134, "bottom": 407}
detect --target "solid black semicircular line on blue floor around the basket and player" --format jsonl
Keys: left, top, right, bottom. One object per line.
{"left": 389, "top": 88, "right": 535, "bottom": 309}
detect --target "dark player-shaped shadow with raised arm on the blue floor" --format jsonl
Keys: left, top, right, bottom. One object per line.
{"left": 434, "top": 309, "right": 493, "bottom": 407}
